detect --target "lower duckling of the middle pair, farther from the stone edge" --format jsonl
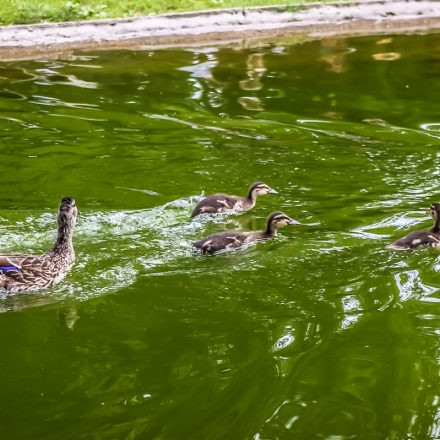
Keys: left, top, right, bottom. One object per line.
{"left": 193, "top": 211, "right": 300, "bottom": 254}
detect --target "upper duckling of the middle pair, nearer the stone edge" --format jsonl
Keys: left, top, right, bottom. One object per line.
{"left": 191, "top": 182, "right": 278, "bottom": 218}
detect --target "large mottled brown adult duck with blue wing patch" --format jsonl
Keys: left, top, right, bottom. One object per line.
{"left": 0, "top": 197, "right": 78, "bottom": 293}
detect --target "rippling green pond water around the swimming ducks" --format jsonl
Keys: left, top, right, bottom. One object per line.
{"left": 0, "top": 34, "right": 440, "bottom": 440}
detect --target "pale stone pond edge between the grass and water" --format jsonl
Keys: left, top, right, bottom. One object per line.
{"left": 0, "top": 0, "right": 440, "bottom": 61}
